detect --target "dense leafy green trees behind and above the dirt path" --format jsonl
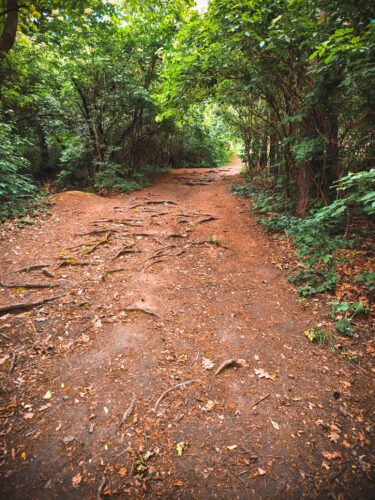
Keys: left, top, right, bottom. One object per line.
{"left": 0, "top": 0, "right": 375, "bottom": 238}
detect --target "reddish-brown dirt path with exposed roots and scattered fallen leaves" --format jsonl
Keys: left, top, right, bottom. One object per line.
{"left": 0, "top": 162, "right": 374, "bottom": 499}
